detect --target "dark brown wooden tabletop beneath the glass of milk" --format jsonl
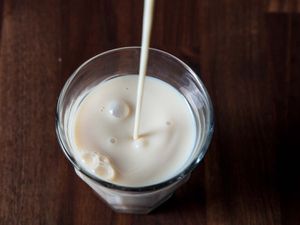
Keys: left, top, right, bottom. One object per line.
{"left": 0, "top": 0, "right": 300, "bottom": 225}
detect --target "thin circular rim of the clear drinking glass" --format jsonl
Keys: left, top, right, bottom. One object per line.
{"left": 55, "top": 46, "right": 214, "bottom": 192}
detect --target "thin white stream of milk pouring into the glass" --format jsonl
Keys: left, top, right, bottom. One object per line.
{"left": 133, "top": 0, "right": 154, "bottom": 140}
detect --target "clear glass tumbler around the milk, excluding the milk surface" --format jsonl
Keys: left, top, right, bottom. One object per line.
{"left": 56, "top": 47, "right": 214, "bottom": 213}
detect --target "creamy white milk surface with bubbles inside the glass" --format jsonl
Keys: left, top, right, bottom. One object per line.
{"left": 70, "top": 75, "right": 196, "bottom": 187}
